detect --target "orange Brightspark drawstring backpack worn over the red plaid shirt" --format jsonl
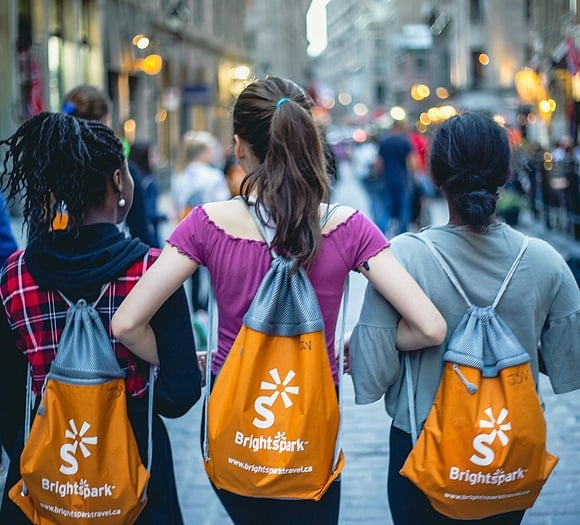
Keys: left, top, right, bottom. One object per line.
{"left": 9, "top": 284, "right": 154, "bottom": 525}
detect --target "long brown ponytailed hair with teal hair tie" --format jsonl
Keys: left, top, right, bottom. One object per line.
{"left": 233, "top": 77, "right": 330, "bottom": 267}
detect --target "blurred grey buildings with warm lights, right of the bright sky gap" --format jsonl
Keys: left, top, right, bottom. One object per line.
{"left": 315, "top": 0, "right": 580, "bottom": 146}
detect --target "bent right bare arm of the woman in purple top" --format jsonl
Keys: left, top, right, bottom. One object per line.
{"left": 359, "top": 248, "right": 447, "bottom": 350}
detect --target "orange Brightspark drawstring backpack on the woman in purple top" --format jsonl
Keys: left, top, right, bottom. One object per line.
{"left": 203, "top": 200, "right": 346, "bottom": 500}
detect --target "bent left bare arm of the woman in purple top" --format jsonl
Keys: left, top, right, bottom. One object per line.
{"left": 112, "top": 245, "right": 198, "bottom": 364}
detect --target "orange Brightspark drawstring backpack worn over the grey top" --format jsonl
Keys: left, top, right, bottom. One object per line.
{"left": 400, "top": 234, "right": 558, "bottom": 519}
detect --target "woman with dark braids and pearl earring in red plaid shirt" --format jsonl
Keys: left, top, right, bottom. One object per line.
{"left": 0, "top": 113, "right": 200, "bottom": 525}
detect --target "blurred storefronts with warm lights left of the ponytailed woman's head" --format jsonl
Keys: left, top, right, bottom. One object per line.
{"left": 0, "top": 0, "right": 251, "bottom": 178}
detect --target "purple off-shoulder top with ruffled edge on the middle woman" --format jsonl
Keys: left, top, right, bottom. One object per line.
{"left": 168, "top": 206, "right": 389, "bottom": 383}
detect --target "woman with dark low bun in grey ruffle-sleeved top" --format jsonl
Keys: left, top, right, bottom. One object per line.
{"left": 350, "top": 113, "right": 580, "bottom": 525}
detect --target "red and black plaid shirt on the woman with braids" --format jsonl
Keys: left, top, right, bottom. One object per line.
{"left": 0, "top": 249, "right": 159, "bottom": 397}
